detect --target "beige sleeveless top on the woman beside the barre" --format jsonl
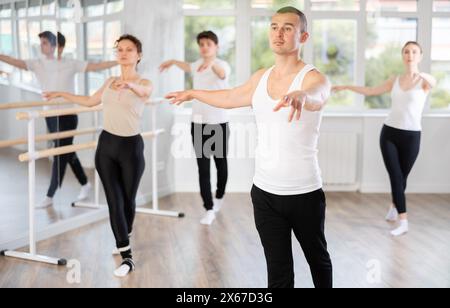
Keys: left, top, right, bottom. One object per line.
{"left": 102, "top": 81, "right": 145, "bottom": 137}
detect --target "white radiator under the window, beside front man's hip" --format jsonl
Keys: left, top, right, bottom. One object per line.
{"left": 319, "top": 133, "right": 358, "bottom": 186}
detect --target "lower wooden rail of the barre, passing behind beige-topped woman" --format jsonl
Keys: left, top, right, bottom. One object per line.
{"left": 19, "top": 129, "right": 164, "bottom": 163}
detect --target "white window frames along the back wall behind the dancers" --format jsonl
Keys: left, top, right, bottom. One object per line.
{"left": 183, "top": 0, "right": 450, "bottom": 114}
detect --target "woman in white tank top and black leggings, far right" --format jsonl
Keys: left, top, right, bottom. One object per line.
{"left": 333, "top": 42, "right": 436, "bottom": 236}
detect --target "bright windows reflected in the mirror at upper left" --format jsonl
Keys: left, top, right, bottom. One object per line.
{"left": 0, "top": 0, "right": 124, "bottom": 93}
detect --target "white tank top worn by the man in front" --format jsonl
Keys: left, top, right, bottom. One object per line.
{"left": 252, "top": 65, "right": 323, "bottom": 196}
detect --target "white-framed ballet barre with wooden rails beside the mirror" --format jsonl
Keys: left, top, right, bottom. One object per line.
{"left": 0, "top": 99, "right": 184, "bottom": 266}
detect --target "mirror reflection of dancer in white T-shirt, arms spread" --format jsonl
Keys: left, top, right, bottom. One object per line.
{"left": 0, "top": 31, "right": 117, "bottom": 208}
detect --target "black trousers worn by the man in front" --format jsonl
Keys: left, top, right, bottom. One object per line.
{"left": 251, "top": 186, "right": 333, "bottom": 288}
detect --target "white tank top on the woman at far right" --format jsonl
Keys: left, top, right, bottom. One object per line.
{"left": 385, "top": 77, "right": 428, "bottom": 131}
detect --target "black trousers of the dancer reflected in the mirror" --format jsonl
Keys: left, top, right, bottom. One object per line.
{"left": 45, "top": 115, "right": 88, "bottom": 198}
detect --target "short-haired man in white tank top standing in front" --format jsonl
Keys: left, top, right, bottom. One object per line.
{"left": 167, "top": 7, "right": 332, "bottom": 288}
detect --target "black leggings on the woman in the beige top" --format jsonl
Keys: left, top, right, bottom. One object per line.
{"left": 95, "top": 131, "right": 145, "bottom": 249}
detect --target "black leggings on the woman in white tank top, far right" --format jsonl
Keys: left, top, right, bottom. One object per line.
{"left": 380, "top": 125, "right": 421, "bottom": 214}
